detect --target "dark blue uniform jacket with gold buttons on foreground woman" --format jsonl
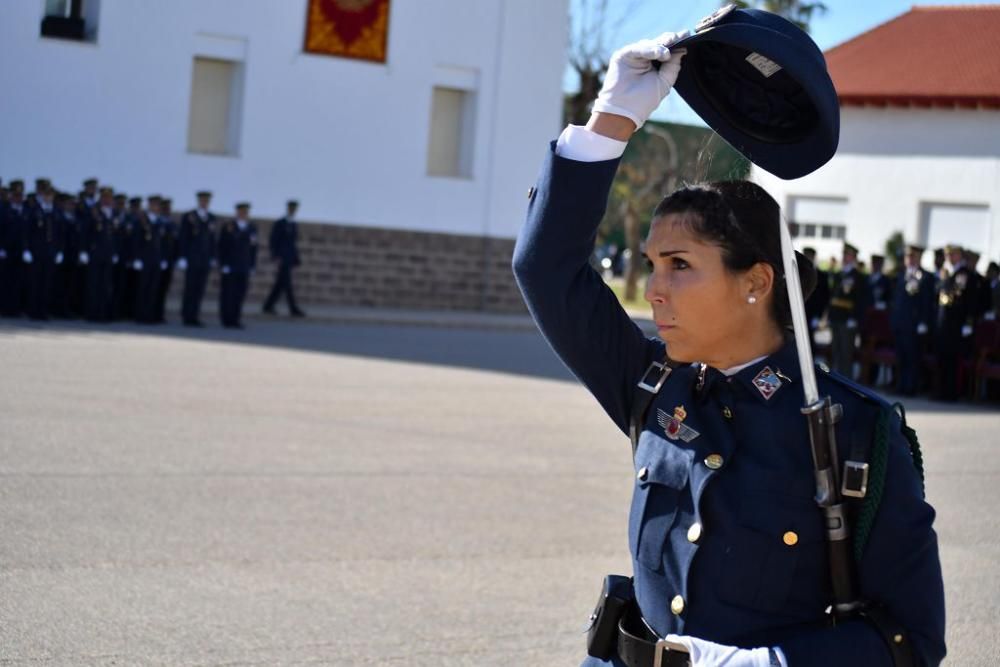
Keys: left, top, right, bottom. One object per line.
{"left": 514, "top": 144, "right": 945, "bottom": 667}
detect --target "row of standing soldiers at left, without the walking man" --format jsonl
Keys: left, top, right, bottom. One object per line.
{"left": 0, "top": 178, "right": 270, "bottom": 328}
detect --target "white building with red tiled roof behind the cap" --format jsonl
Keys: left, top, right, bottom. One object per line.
{"left": 753, "top": 6, "right": 1000, "bottom": 271}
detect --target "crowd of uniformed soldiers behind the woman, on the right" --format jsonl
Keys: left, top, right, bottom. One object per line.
{"left": 803, "top": 243, "right": 1000, "bottom": 400}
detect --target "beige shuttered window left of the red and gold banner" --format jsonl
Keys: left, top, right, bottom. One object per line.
{"left": 188, "top": 56, "right": 243, "bottom": 155}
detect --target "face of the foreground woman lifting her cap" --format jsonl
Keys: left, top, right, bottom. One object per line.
{"left": 645, "top": 213, "right": 767, "bottom": 365}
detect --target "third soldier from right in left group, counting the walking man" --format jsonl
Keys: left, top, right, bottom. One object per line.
{"left": 177, "top": 190, "right": 217, "bottom": 327}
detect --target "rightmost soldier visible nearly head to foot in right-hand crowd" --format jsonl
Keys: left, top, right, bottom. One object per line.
{"left": 937, "top": 245, "right": 979, "bottom": 401}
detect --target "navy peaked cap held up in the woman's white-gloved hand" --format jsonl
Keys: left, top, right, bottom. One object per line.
{"left": 668, "top": 5, "right": 840, "bottom": 179}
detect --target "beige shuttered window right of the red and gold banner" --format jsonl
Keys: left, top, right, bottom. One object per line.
{"left": 427, "top": 86, "right": 476, "bottom": 178}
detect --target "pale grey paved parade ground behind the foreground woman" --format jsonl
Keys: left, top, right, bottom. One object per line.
{"left": 0, "top": 320, "right": 1000, "bottom": 667}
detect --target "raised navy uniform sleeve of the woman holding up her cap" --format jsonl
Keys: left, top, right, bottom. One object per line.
{"left": 513, "top": 142, "right": 663, "bottom": 432}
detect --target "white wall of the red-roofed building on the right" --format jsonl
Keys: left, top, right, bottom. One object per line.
{"left": 751, "top": 108, "right": 1000, "bottom": 270}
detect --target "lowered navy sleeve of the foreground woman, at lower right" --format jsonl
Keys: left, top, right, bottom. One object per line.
{"left": 781, "top": 421, "right": 946, "bottom": 667}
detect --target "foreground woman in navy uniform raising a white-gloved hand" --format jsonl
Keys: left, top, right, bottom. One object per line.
{"left": 514, "top": 34, "right": 945, "bottom": 667}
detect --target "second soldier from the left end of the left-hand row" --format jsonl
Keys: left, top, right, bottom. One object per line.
{"left": 24, "top": 183, "right": 64, "bottom": 320}
